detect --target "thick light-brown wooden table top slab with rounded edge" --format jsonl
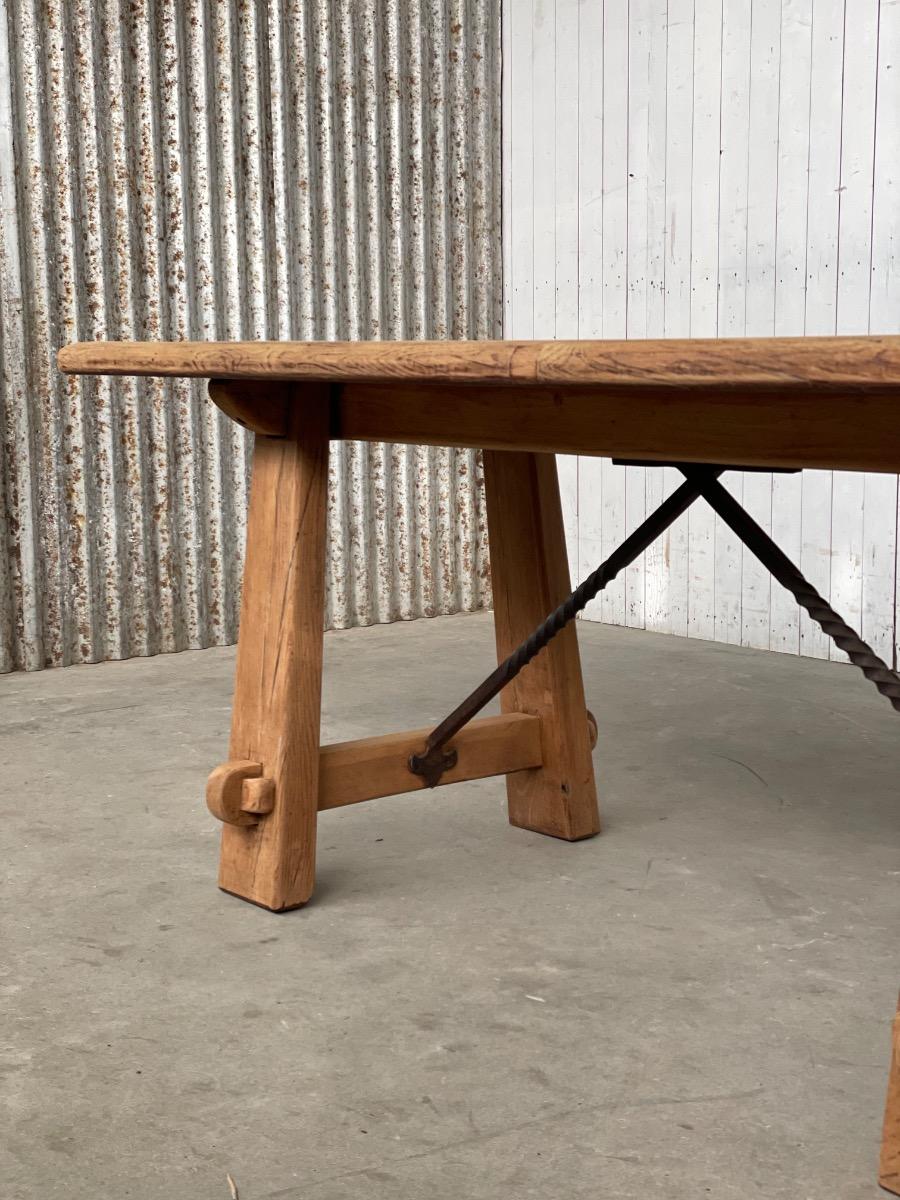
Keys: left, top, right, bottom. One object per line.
{"left": 59, "top": 336, "right": 900, "bottom": 390}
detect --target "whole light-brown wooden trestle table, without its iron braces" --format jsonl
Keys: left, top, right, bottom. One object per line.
{"left": 59, "top": 336, "right": 900, "bottom": 1194}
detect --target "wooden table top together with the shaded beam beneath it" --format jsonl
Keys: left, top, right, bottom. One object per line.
{"left": 59, "top": 336, "right": 900, "bottom": 472}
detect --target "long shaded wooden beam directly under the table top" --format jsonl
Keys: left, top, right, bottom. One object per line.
{"left": 332, "top": 383, "right": 900, "bottom": 472}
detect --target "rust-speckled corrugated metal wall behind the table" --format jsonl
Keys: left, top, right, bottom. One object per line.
{"left": 0, "top": 0, "right": 500, "bottom": 671}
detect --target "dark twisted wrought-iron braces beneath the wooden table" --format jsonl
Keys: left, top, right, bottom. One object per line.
{"left": 409, "top": 463, "right": 900, "bottom": 787}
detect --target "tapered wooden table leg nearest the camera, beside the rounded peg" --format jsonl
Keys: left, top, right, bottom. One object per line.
{"left": 218, "top": 386, "right": 329, "bottom": 910}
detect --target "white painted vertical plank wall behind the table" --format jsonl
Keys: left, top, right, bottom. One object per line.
{"left": 503, "top": 0, "right": 900, "bottom": 661}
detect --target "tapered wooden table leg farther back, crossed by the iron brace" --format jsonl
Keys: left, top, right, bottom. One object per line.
{"left": 484, "top": 450, "right": 600, "bottom": 841}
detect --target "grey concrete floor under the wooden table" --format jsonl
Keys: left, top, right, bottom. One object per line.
{"left": 0, "top": 616, "right": 900, "bottom": 1200}
